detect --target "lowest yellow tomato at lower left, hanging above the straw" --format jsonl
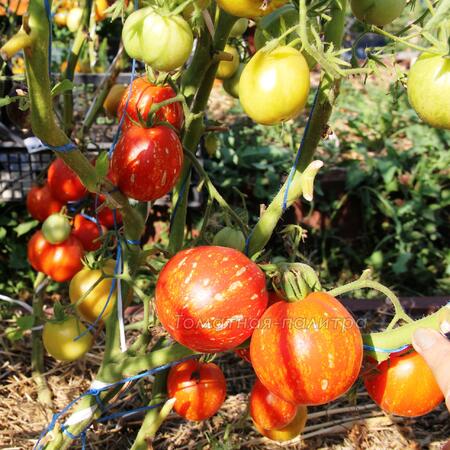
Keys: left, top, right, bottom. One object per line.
{"left": 42, "top": 316, "right": 93, "bottom": 361}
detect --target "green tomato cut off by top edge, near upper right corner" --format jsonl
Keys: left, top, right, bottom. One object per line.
{"left": 351, "top": 0, "right": 406, "bottom": 27}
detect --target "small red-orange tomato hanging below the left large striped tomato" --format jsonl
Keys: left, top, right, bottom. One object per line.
{"left": 167, "top": 359, "right": 227, "bottom": 421}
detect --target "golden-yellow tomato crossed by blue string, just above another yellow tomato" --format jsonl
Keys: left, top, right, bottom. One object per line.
{"left": 69, "top": 260, "right": 117, "bottom": 322}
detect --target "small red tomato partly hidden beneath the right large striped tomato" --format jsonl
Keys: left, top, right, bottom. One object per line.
{"left": 250, "top": 379, "right": 297, "bottom": 430}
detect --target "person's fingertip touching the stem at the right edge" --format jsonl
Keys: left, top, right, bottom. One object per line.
{"left": 413, "top": 328, "right": 450, "bottom": 410}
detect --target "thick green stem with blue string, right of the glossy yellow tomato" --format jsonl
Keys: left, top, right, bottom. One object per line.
{"left": 248, "top": 0, "right": 346, "bottom": 256}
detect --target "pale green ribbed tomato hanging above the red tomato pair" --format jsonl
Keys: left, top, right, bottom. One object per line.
{"left": 122, "top": 6, "right": 194, "bottom": 72}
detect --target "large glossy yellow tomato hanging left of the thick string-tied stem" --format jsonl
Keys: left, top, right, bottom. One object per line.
{"left": 239, "top": 46, "right": 310, "bottom": 125}
